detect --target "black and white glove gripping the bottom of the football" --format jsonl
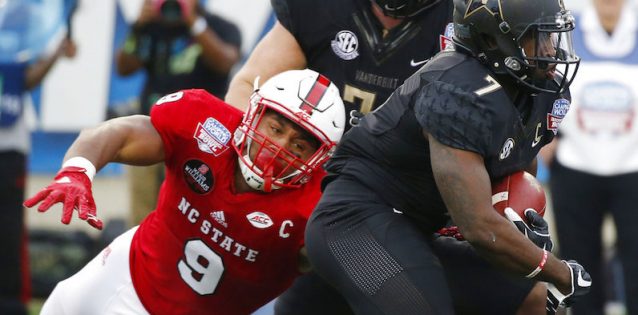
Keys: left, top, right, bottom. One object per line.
{"left": 504, "top": 208, "right": 554, "bottom": 252}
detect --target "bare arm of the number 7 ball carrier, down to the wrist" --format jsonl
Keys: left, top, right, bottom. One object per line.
{"left": 428, "top": 136, "right": 571, "bottom": 296}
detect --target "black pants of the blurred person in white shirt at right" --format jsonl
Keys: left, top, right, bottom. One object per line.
{"left": 550, "top": 162, "right": 638, "bottom": 315}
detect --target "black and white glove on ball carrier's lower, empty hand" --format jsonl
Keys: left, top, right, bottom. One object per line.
{"left": 546, "top": 260, "right": 591, "bottom": 314}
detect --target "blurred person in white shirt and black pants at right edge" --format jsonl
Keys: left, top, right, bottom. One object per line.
{"left": 542, "top": 0, "right": 638, "bottom": 315}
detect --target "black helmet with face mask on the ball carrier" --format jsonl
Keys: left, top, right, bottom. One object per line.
{"left": 453, "top": 0, "right": 580, "bottom": 93}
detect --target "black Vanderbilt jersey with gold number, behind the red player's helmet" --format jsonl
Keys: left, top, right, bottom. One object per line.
{"left": 271, "top": 0, "right": 452, "bottom": 130}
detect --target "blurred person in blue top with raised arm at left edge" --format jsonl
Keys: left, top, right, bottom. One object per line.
{"left": 0, "top": 32, "right": 76, "bottom": 314}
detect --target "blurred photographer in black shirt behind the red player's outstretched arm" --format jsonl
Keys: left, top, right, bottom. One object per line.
{"left": 117, "top": 0, "right": 241, "bottom": 224}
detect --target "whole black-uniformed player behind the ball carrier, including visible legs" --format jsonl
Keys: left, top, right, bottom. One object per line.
{"left": 226, "top": 0, "right": 564, "bottom": 315}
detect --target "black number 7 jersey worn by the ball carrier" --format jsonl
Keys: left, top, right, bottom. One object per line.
{"left": 326, "top": 51, "right": 570, "bottom": 230}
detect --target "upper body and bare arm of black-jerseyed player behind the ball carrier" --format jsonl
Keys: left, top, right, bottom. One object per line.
{"left": 226, "top": 0, "right": 452, "bottom": 129}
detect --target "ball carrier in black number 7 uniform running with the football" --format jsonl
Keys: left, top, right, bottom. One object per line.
{"left": 306, "top": 0, "right": 592, "bottom": 315}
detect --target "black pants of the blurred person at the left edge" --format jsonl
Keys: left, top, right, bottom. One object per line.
{"left": 0, "top": 151, "right": 28, "bottom": 315}
